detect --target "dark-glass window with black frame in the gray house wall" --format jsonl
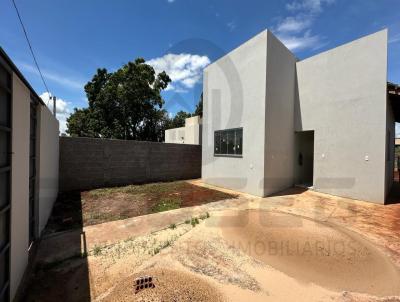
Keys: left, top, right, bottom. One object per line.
{"left": 214, "top": 128, "right": 243, "bottom": 157}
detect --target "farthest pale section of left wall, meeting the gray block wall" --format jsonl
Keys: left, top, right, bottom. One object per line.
{"left": 38, "top": 105, "right": 59, "bottom": 234}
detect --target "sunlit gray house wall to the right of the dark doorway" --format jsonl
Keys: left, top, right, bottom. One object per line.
{"left": 295, "top": 30, "right": 387, "bottom": 203}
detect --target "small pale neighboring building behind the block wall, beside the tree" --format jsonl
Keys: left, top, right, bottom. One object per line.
{"left": 165, "top": 116, "right": 202, "bottom": 145}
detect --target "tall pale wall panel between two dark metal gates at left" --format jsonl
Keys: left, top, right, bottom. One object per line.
{"left": 10, "top": 73, "right": 31, "bottom": 298}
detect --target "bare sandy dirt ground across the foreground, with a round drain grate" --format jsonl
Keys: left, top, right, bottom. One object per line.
{"left": 24, "top": 182, "right": 400, "bottom": 302}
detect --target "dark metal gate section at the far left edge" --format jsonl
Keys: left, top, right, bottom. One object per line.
{"left": 0, "top": 57, "right": 12, "bottom": 301}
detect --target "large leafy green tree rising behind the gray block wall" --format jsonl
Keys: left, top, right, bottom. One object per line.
{"left": 67, "top": 58, "right": 171, "bottom": 141}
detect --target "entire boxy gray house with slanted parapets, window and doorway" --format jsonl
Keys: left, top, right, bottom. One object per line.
{"left": 202, "top": 30, "right": 400, "bottom": 203}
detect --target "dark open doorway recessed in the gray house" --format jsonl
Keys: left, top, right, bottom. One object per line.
{"left": 294, "top": 131, "right": 314, "bottom": 188}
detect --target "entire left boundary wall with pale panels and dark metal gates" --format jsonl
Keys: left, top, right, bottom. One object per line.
{"left": 0, "top": 48, "right": 58, "bottom": 301}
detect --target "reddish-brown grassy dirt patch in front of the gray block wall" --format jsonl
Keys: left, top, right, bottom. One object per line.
{"left": 46, "top": 181, "right": 236, "bottom": 234}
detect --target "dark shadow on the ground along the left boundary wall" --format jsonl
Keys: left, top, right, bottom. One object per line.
{"left": 20, "top": 192, "right": 91, "bottom": 302}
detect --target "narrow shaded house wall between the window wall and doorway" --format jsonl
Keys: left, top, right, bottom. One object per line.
{"left": 264, "top": 32, "right": 296, "bottom": 195}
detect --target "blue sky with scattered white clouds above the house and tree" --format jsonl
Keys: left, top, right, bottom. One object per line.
{"left": 0, "top": 0, "right": 400, "bottom": 130}
